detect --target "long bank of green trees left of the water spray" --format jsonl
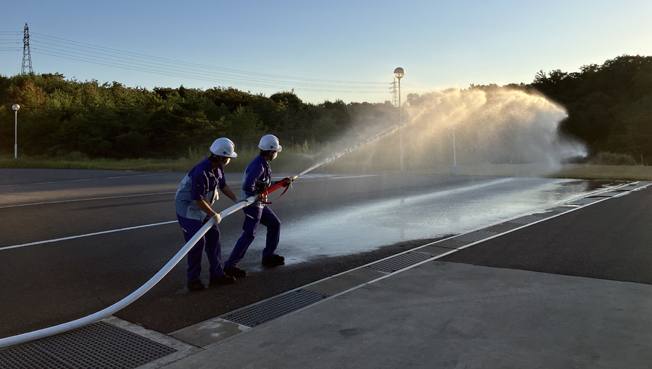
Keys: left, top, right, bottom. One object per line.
{"left": 0, "top": 73, "right": 396, "bottom": 160}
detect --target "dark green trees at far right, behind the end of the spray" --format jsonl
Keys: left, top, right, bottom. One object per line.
{"left": 529, "top": 55, "right": 652, "bottom": 161}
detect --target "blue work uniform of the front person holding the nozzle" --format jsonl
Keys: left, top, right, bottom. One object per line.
{"left": 224, "top": 155, "right": 281, "bottom": 268}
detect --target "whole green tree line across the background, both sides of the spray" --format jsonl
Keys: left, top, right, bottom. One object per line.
{"left": 0, "top": 55, "right": 652, "bottom": 163}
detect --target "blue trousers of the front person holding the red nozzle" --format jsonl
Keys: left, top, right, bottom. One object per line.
{"left": 224, "top": 205, "right": 281, "bottom": 268}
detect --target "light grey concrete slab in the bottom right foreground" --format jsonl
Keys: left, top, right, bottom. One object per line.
{"left": 162, "top": 261, "right": 652, "bottom": 369}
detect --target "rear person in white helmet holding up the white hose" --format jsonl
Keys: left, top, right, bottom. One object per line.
{"left": 174, "top": 137, "right": 241, "bottom": 291}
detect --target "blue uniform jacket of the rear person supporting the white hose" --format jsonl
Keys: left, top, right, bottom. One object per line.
{"left": 174, "top": 158, "right": 226, "bottom": 220}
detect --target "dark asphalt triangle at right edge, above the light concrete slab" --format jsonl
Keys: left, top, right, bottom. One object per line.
{"left": 440, "top": 183, "right": 652, "bottom": 284}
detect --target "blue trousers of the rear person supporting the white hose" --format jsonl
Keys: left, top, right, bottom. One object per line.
{"left": 177, "top": 214, "right": 224, "bottom": 282}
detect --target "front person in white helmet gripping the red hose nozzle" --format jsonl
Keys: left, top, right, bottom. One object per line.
{"left": 224, "top": 135, "right": 292, "bottom": 278}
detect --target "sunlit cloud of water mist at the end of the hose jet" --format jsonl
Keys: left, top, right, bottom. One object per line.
{"left": 318, "top": 88, "right": 587, "bottom": 175}
